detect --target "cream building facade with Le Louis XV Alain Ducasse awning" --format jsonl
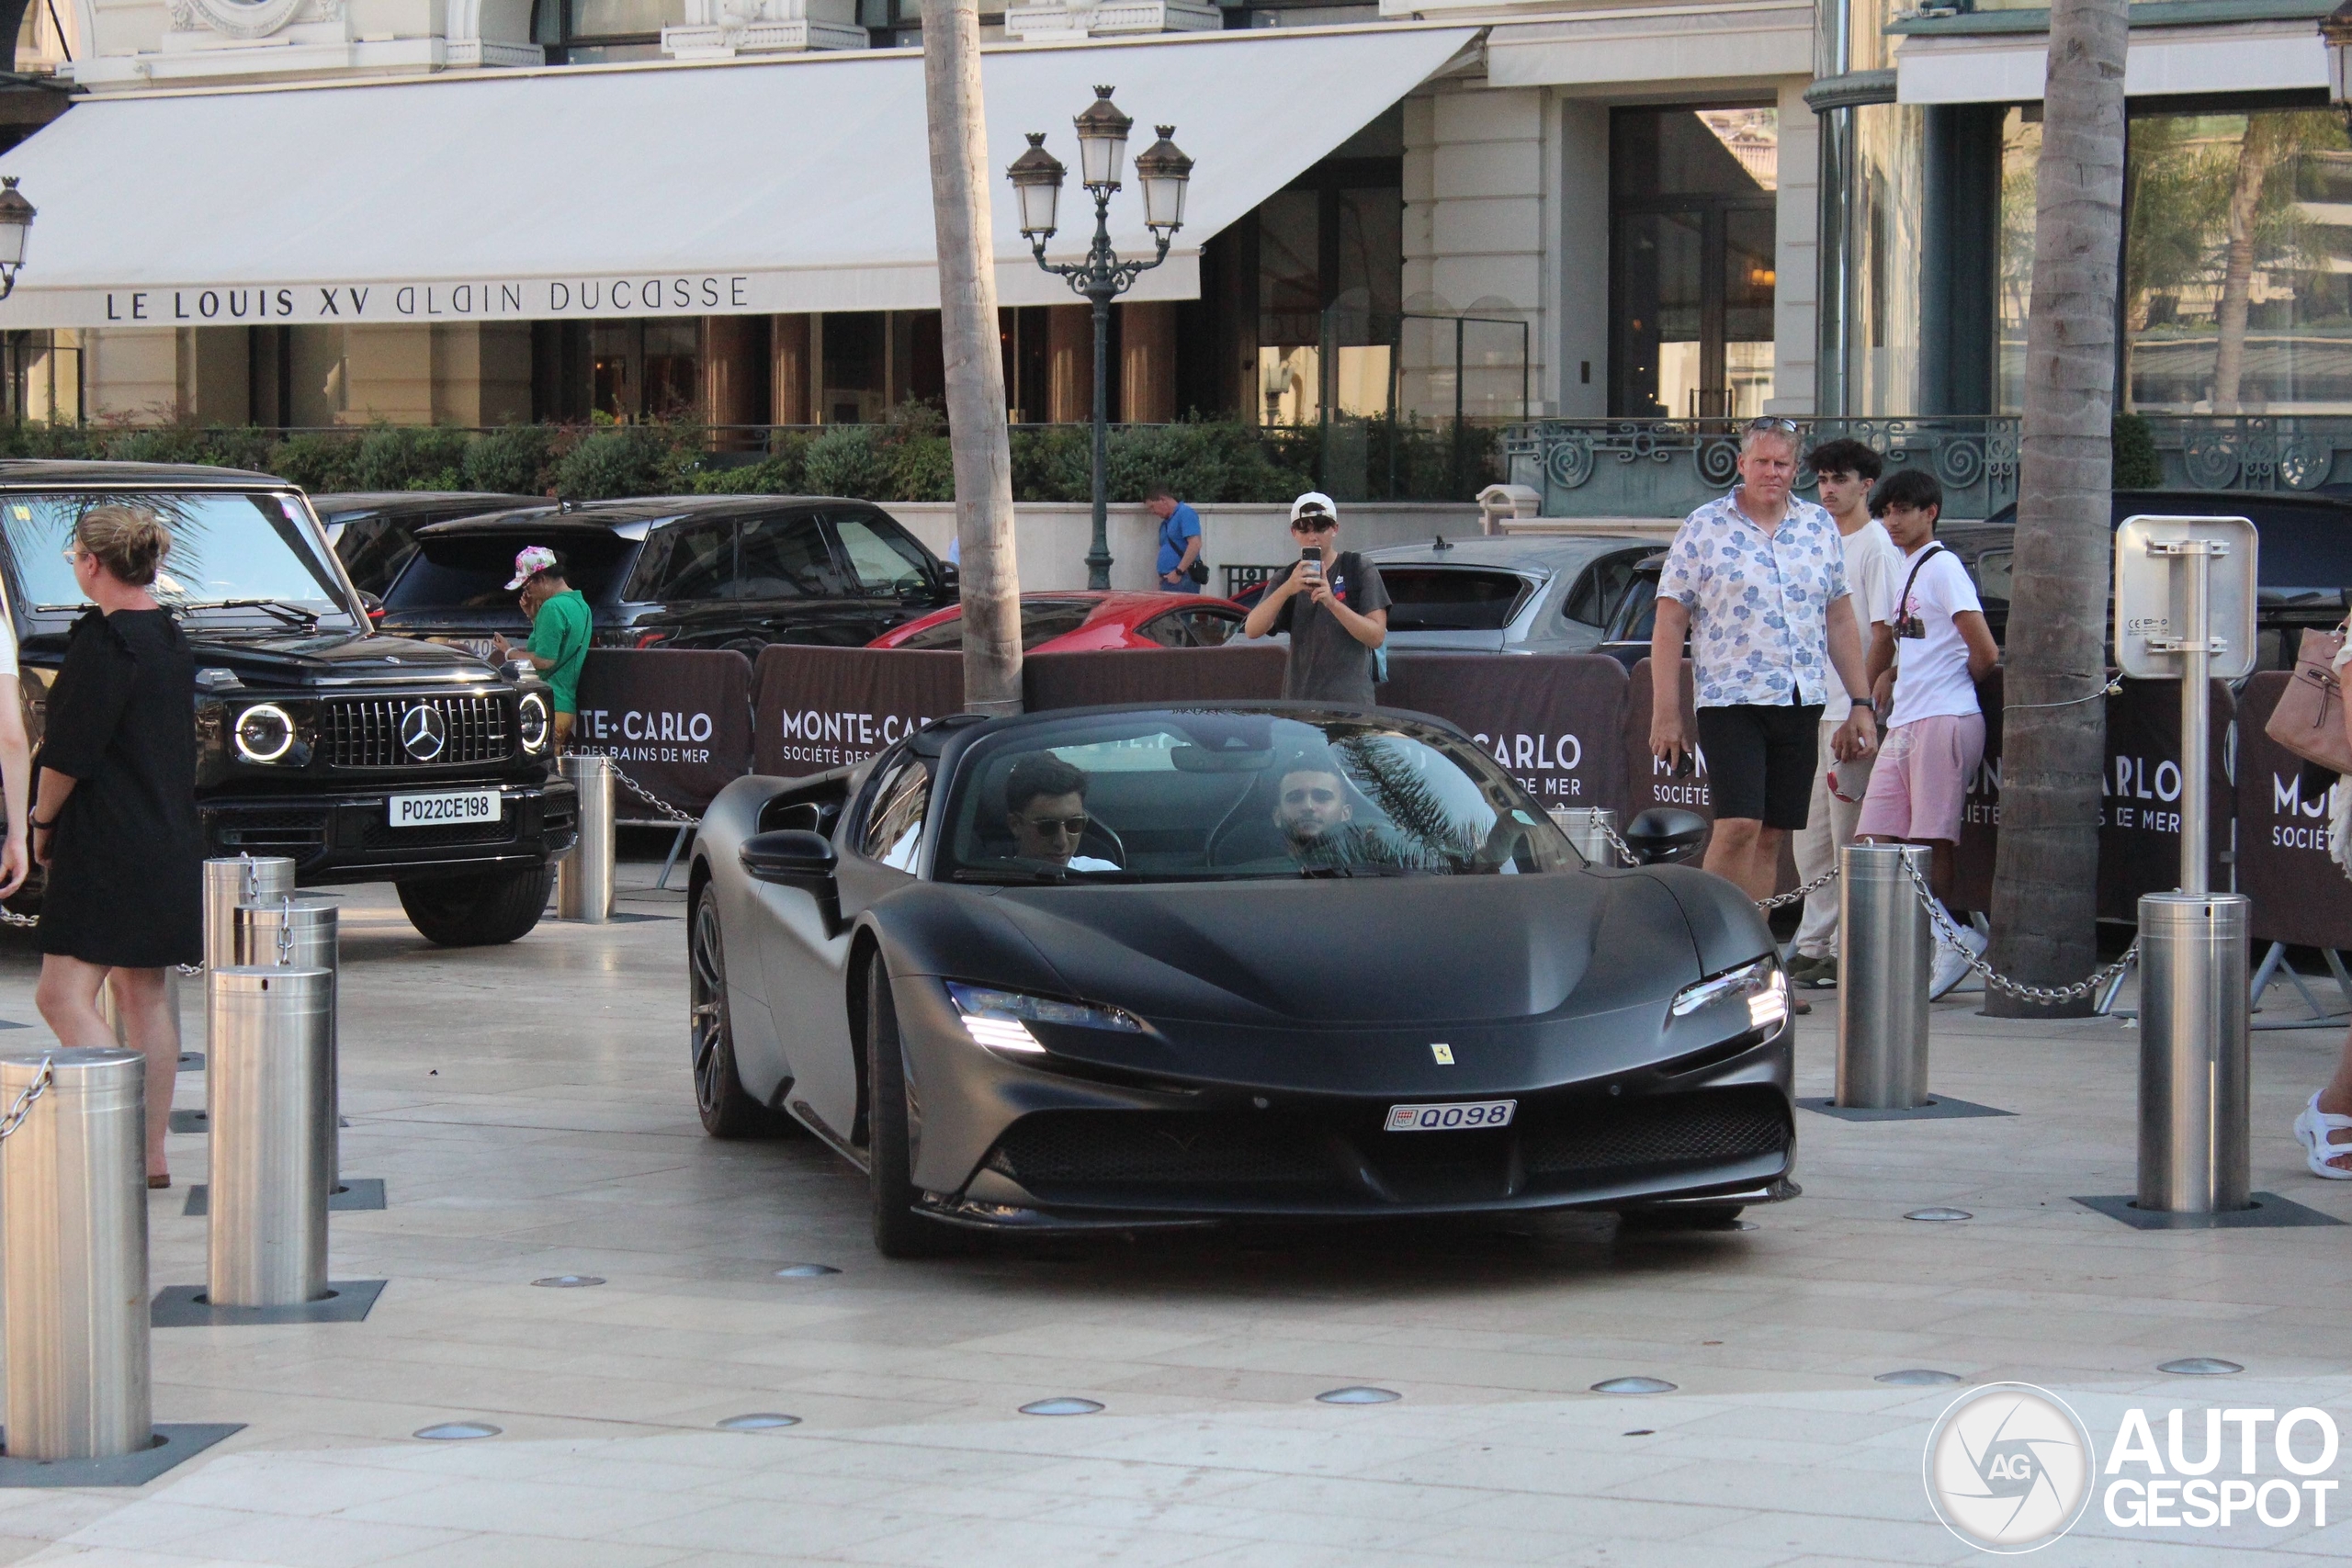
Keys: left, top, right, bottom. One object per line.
{"left": 0, "top": 0, "right": 2352, "bottom": 502}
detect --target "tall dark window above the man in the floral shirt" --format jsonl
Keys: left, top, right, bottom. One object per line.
{"left": 1609, "top": 108, "right": 1781, "bottom": 419}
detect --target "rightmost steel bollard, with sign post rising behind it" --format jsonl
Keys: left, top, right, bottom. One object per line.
{"left": 2138, "top": 894, "right": 2253, "bottom": 1213}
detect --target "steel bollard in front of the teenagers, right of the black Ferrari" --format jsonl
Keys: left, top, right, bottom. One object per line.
{"left": 1837, "top": 844, "right": 1936, "bottom": 1110}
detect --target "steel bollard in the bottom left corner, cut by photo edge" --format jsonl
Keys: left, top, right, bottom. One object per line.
{"left": 0, "top": 1048, "right": 155, "bottom": 1460}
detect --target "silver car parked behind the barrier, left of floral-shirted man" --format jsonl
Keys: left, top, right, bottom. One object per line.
{"left": 1364, "top": 534, "right": 1658, "bottom": 653}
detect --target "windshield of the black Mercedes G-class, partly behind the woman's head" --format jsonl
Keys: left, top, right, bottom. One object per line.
{"left": 0, "top": 491, "right": 356, "bottom": 626}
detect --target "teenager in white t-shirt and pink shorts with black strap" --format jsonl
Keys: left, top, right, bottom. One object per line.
{"left": 1856, "top": 468, "right": 2002, "bottom": 997}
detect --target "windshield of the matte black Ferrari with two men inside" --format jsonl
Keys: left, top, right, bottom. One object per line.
{"left": 936, "top": 710, "right": 1583, "bottom": 884}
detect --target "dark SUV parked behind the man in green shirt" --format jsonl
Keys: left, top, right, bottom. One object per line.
{"left": 381, "top": 496, "right": 957, "bottom": 659}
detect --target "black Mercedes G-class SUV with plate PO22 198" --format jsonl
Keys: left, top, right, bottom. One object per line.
{"left": 0, "top": 461, "right": 579, "bottom": 947}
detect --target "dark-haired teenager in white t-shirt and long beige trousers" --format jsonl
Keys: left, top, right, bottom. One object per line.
{"left": 1788, "top": 437, "right": 1903, "bottom": 987}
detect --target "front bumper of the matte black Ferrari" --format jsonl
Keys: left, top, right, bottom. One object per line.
{"left": 899, "top": 980, "right": 1797, "bottom": 1229}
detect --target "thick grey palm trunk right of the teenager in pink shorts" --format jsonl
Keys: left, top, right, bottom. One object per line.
{"left": 1985, "top": 0, "right": 2126, "bottom": 1018}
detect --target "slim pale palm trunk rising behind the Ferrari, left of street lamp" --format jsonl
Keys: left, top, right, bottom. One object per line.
{"left": 922, "top": 0, "right": 1021, "bottom": 712}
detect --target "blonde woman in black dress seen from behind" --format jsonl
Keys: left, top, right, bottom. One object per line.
{"left": 30, "top": 505, "right": 205, "bottom": 1187}
